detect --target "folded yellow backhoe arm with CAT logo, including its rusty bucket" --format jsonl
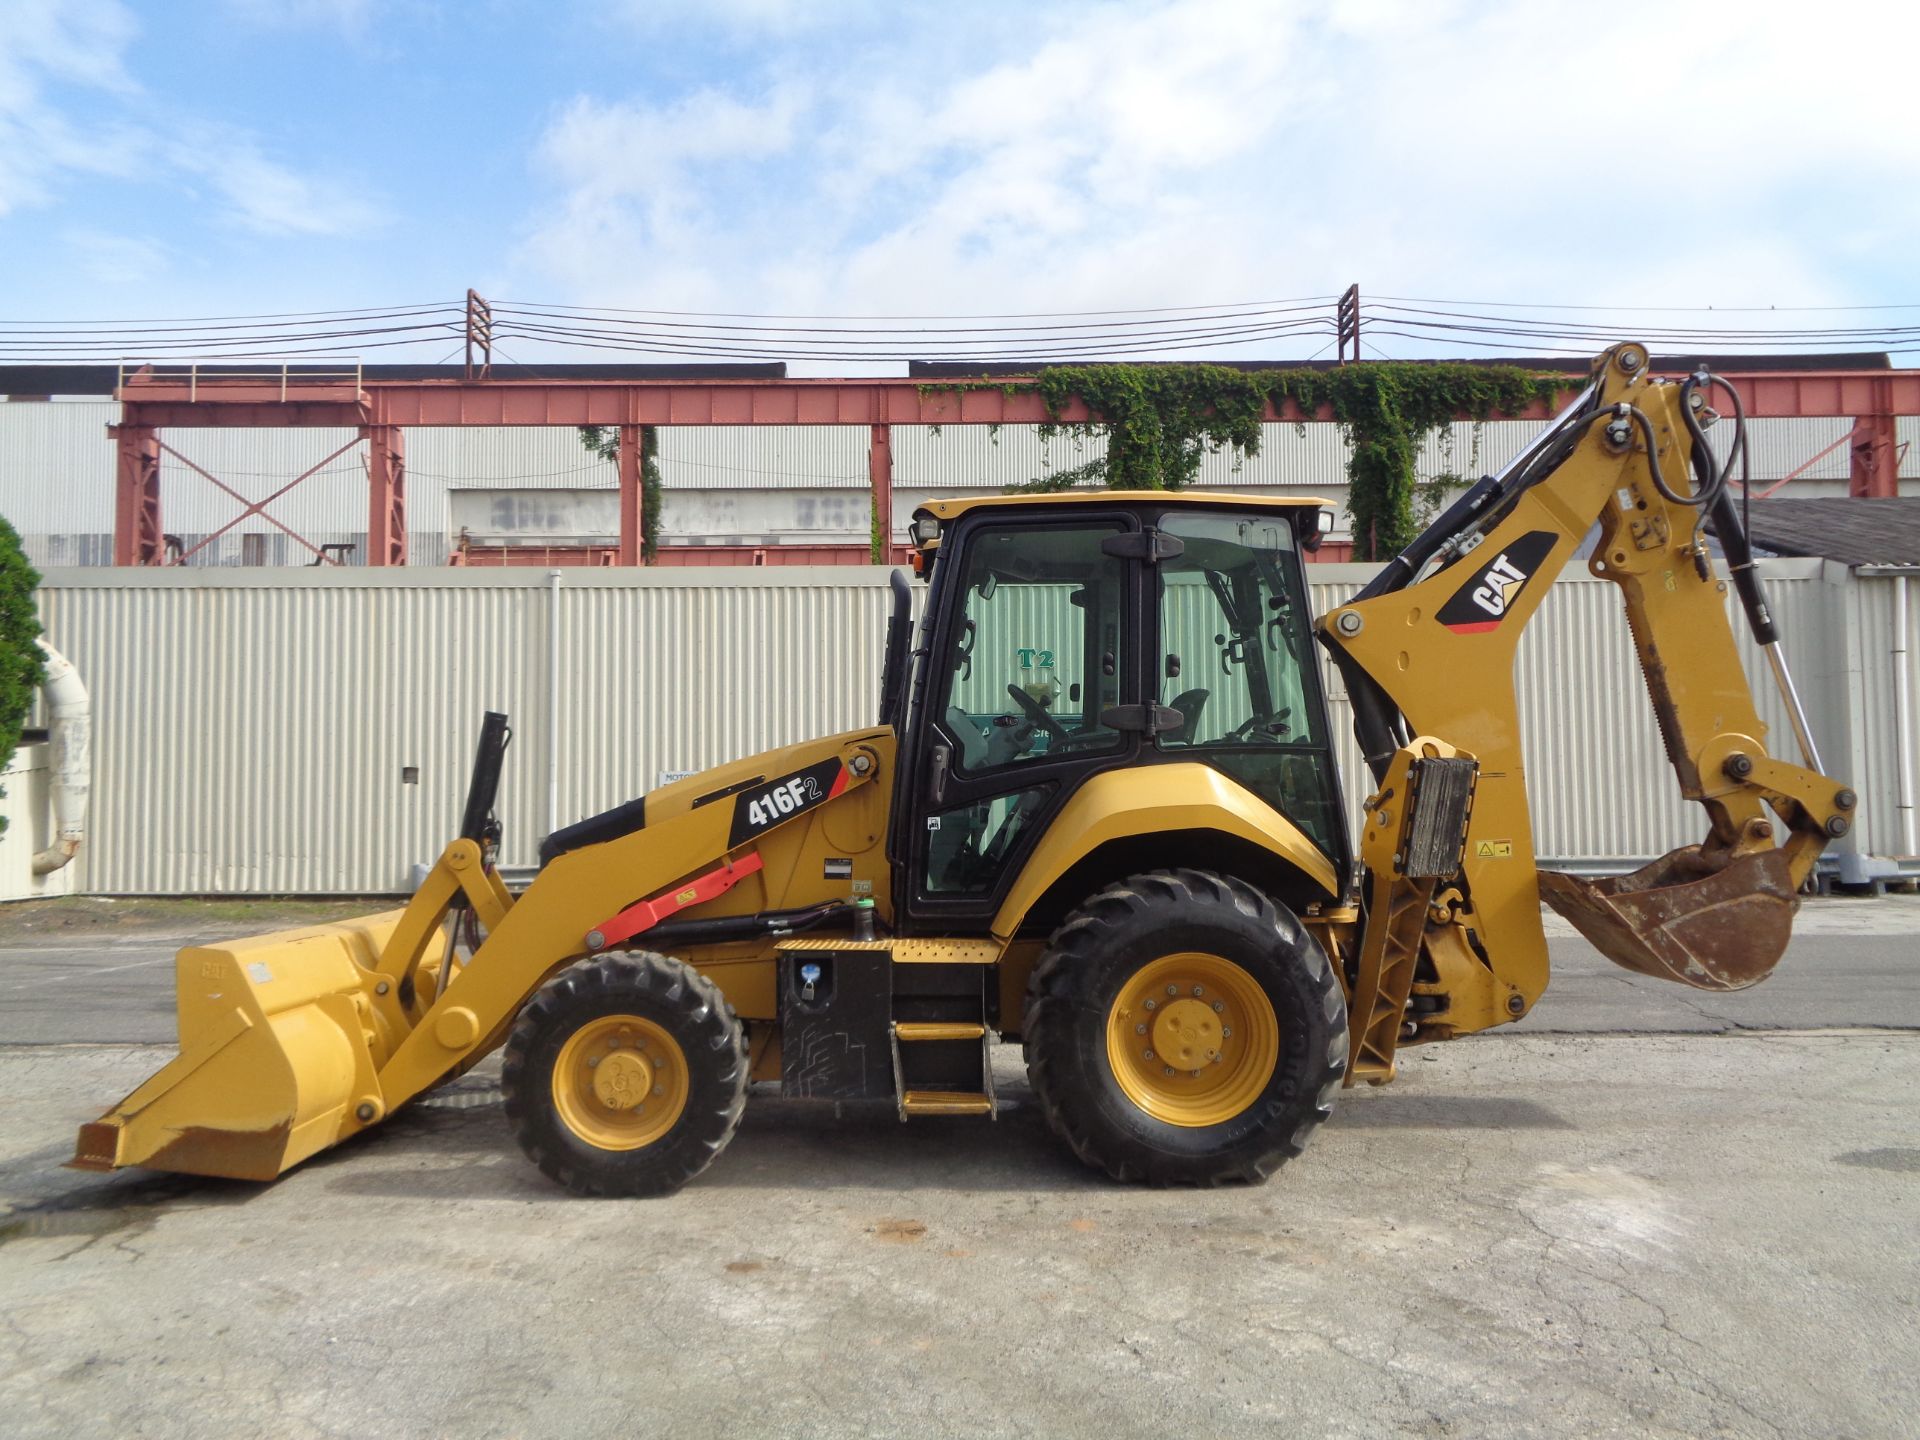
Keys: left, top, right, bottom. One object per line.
{"left": 1319, "top": 344, "right": 1855, "bottom": 1077}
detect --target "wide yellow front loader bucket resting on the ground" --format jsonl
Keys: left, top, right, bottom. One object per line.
{"left": 71, "top": 910, "right": 401, "bottom": 1181}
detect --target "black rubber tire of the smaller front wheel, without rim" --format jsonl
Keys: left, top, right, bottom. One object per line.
{"left": 501, "top": 950, "right": 749, "bottom": 1196}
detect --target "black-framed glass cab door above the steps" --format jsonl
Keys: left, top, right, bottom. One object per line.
{"left": 895, "top": 507, "right": 1142, "bottom": 933}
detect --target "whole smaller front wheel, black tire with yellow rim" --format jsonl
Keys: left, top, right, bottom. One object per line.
{"left": 501, "top": 952, "right": 749, "bottom": 1196}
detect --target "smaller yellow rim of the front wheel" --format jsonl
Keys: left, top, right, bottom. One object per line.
{"left": 553, "top": 1016, "right": 691, "bottom": 1150}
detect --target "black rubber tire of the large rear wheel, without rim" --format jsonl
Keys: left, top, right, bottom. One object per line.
{"left": 1023, "top": 870, "right": 1348, "bottom": 1187}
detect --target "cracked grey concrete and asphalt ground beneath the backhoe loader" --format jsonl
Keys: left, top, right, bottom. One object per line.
{"left": 0, "top": 902, "right": 1920, "bottom": 1440}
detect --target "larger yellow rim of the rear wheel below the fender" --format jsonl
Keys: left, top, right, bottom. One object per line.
{"left": 1106, "top": 950, "right": 1281, "bottom": 1129}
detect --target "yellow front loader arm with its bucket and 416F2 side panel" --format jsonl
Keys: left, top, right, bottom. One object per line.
{"left": 71, "top": 733, "right": 893, "bottom": 1181}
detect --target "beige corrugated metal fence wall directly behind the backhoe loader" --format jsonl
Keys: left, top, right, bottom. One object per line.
{"left": 40, "top": 561, "right": 1920, "bottom": 895}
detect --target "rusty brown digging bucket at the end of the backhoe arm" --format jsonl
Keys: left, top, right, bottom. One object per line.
{"left": 1540, "top": 845, "right": 1799, "bottom": 991}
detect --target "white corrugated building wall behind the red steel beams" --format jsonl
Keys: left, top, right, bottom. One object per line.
{"left": 0, "top": 399, "right": 1920, "bottom": 566}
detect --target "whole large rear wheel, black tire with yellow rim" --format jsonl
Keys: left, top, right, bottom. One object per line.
{"left": 1023, "top": 870, "right": 1348, "bottom": 1185}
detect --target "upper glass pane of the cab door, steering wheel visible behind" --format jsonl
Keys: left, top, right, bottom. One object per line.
{"left": 939, "top": 524, "right": 1125, "bottom": 774}
